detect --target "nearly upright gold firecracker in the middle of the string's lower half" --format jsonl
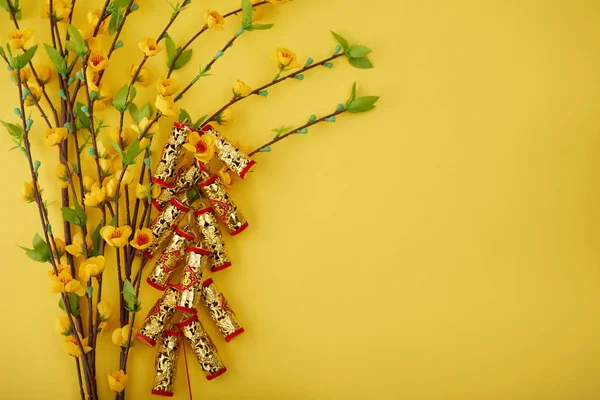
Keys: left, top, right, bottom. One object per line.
{"left": 173, "top": 247, "right": 210, "bottom": 314}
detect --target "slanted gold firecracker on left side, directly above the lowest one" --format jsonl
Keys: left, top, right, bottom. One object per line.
{"left": 136, "top": 287, "right": 179, "bottom": 347}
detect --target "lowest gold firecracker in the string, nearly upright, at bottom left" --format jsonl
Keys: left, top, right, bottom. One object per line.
{"left": 152, "top": 330, "right": 182, "bottom": 397}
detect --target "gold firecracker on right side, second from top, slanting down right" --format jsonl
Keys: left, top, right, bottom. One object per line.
{"left": 198, "top": 171, "right": 248, "bottom": 236}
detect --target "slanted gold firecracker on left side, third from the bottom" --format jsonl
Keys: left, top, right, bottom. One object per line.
{"left": 146, "top": 225, "right": 194, "bottom": 290}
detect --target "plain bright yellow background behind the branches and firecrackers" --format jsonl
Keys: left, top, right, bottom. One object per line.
{"left": 0, "top": 0, "right": 600, "bottom": 399}
